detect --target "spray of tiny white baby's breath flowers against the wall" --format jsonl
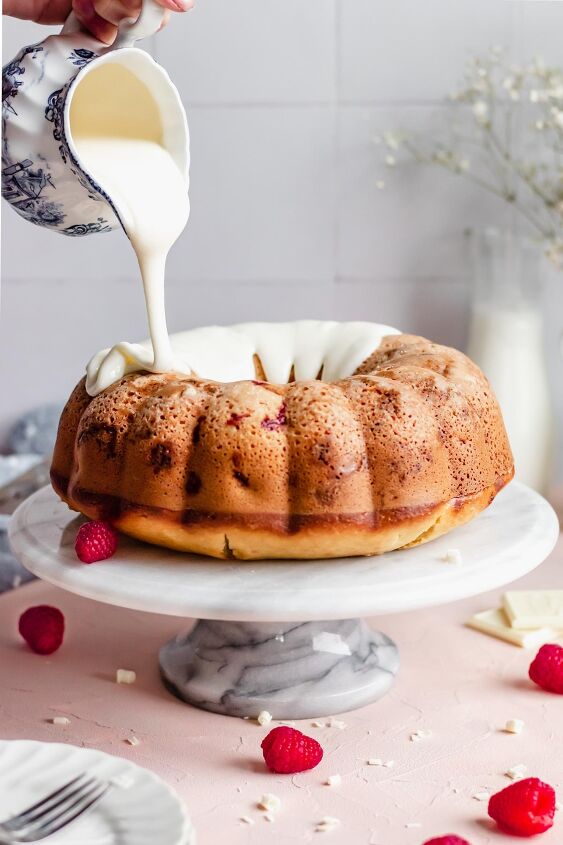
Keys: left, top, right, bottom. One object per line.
{"left": 376, "top": 46, "right": 563, "bottom": 269}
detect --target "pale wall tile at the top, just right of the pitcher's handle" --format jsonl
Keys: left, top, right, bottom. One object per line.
{"left": 155, "top": 0, "right": 338, "bottom": 106}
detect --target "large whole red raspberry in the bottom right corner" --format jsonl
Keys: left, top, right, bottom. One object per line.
{"left": 489, "top": 778, "right": 555, "bottom": 836}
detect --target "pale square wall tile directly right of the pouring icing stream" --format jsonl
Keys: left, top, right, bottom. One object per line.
{"left": 165, "top": 105, "right": 336, "bottom": 284}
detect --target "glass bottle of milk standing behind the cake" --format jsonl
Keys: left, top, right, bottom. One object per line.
{"left": 467, "top": 229, "right": 555, "bottom": 493}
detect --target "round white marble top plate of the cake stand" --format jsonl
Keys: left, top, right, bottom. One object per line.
{"left": 10, "top": 482, "right": 559, "bottom": 622}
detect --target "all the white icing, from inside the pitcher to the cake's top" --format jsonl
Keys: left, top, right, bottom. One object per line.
{"left": 71, "top": 60, "right": 397, "bottom": 396}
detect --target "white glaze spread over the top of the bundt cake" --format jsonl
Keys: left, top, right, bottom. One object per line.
{"left": 86, "top": 320, "right": 399, "bottom": 396}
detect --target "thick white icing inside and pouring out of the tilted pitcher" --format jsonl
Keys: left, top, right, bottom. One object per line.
{"left": 71, "top": 62, "right": 189, "bottom": 372}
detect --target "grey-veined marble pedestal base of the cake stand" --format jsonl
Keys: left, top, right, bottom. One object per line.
{"left": 160, "top": 619, "right": 399, "bottom": 719}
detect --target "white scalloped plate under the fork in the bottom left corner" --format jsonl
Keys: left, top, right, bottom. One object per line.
{"left": 0, "top": 740, "right": 195, "bottom": 845}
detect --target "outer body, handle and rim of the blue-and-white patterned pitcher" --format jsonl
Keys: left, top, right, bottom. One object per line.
{"left": 2, "top": 0, "right": 189, "bottom": 236}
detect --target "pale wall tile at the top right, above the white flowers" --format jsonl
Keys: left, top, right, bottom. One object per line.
{"left": 339, "top": 0, "right": 513, "bottom": 103}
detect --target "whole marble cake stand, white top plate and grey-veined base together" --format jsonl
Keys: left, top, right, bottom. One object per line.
{"left": 10, "top": 482, "right": 559, "bottom": 719}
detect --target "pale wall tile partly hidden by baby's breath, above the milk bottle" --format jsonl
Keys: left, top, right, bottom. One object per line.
{"left": 337, "top": 105, "right": 506, "bottom": 279}
